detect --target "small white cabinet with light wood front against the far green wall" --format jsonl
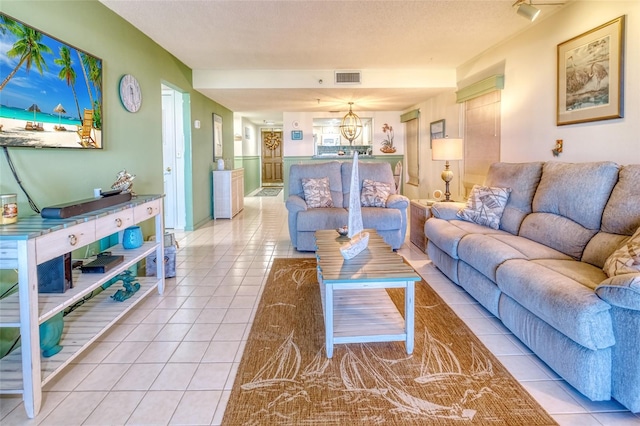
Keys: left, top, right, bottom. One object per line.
{"left": 213, "top": 169, "right": 244, "bottom": 219}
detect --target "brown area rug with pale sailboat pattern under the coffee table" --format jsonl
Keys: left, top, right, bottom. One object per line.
{"left": 222, "top": 259, "right": 557, "bottom": 426}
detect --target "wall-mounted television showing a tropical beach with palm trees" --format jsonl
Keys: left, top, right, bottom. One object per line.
{"left": 0, "top": 13, "right": 103, "bottom": 149}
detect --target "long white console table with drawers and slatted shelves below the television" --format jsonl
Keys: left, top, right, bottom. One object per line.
{"left": 0, "top": 195, "right": 164, "bottom": 418}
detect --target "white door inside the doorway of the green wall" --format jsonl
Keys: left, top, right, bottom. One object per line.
{"left": 162, "top": 84, "right": 186, "bottom": 230}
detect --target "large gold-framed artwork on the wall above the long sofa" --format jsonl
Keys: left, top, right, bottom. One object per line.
{"left": 556, "top": 16, "right": 624, "bottom": 126}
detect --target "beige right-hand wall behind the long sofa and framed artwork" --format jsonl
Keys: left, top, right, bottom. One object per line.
{"left": 407, "top": 0, "right": 640, "bottom": 198}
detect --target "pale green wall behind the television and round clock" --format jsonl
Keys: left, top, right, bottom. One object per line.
{"left": 0, "top": 0, "right": 233, "bottom": 229}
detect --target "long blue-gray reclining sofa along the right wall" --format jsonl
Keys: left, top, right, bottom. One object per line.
{"left": 424, "top": 162, "right": 640, "bottom": 412}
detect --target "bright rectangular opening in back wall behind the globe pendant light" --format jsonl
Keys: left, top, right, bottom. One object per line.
{"left": 313, "top": 118, "right": 373, "bottom": 155}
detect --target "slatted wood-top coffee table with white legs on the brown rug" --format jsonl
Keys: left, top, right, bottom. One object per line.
{"left": 315, "top": 229, "right": 421, "bottom": 358}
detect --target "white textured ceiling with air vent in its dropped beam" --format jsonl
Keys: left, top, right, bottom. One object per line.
{"left": 101, "top": 0, "right": 561, "bottom": 121}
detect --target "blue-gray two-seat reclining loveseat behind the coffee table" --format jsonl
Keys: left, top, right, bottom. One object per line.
{"left": 286, "top": 161, "right": 409, "bottom": 251}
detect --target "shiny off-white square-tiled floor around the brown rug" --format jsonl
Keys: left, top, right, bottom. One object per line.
{"left": 0, "top": 193, "right": 640, "bottom": 426}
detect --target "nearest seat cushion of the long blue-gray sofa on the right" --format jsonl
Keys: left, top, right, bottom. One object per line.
{"left": 496, "top": 259, "right": 615, "bottom": 350}
